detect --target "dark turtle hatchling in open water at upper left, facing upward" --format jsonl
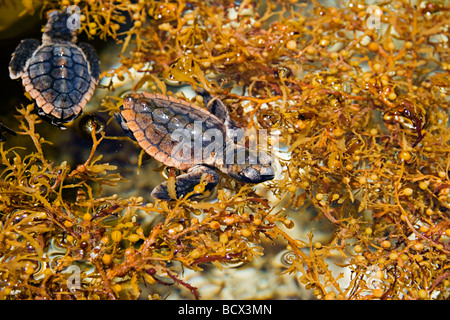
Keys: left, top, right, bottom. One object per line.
{"left": 9, "top": 10, "right": 100, "bottom": 128}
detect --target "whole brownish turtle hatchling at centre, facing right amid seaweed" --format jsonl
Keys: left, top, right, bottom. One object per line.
{"left": 116, "top": 91, "right": 274, "bottom": 200}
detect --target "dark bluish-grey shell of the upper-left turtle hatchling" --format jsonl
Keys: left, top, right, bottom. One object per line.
{"left": 22, "top": 42, "right": 95, "bottom": 123}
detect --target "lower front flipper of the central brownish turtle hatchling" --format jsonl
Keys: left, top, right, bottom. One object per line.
{"left": 152, "top": 165, "right": 219, "bottom": 201}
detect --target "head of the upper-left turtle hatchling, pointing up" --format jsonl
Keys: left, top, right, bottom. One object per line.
{"left": 42, "top": 10, "right": 77, "bottom": 42}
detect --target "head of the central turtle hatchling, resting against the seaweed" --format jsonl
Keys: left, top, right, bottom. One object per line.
{"left": 226, "top": 147, "right": 275, "bottom": 183}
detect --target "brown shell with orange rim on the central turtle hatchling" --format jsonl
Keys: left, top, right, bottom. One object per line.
{"left": 117, "top": 92, "right": 227, "bottom": 170}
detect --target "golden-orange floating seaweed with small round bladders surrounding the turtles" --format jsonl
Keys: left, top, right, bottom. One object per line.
{"left": 0, "top": 0, "right": 450, "bottom": 299}
